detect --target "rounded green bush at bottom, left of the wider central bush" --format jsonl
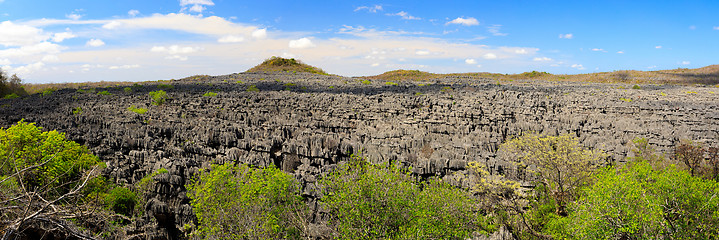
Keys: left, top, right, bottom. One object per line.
{"left": 188, "top": 163, "right": 307, "bottom": 239}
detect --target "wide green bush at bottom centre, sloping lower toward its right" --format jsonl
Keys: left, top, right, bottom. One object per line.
{"left": 321, "top": 157, "right": 494, "bottom": 239}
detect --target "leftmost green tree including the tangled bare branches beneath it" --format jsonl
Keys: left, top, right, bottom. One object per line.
{"left": 0, "top": 121, "right": 103, "bottom": 237}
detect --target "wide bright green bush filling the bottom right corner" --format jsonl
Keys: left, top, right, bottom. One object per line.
{"left": 566, "top": 161, "right": 719, "bottom": 239}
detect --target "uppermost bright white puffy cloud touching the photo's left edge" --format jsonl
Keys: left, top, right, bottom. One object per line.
{"left": 0, "top": 21, "right": 49, "bottom": 47}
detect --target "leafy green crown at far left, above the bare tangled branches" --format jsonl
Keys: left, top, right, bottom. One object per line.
{"left": 0, "top": 120, "right": 101, "bottom": 194}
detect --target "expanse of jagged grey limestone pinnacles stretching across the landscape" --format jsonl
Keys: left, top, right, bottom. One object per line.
{"left": 0, "top": 71, "right": 719, "bottom": 239}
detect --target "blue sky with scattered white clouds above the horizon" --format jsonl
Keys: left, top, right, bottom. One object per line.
{"left": 0, "top": 0, "right": 719, "bottom": 83}
